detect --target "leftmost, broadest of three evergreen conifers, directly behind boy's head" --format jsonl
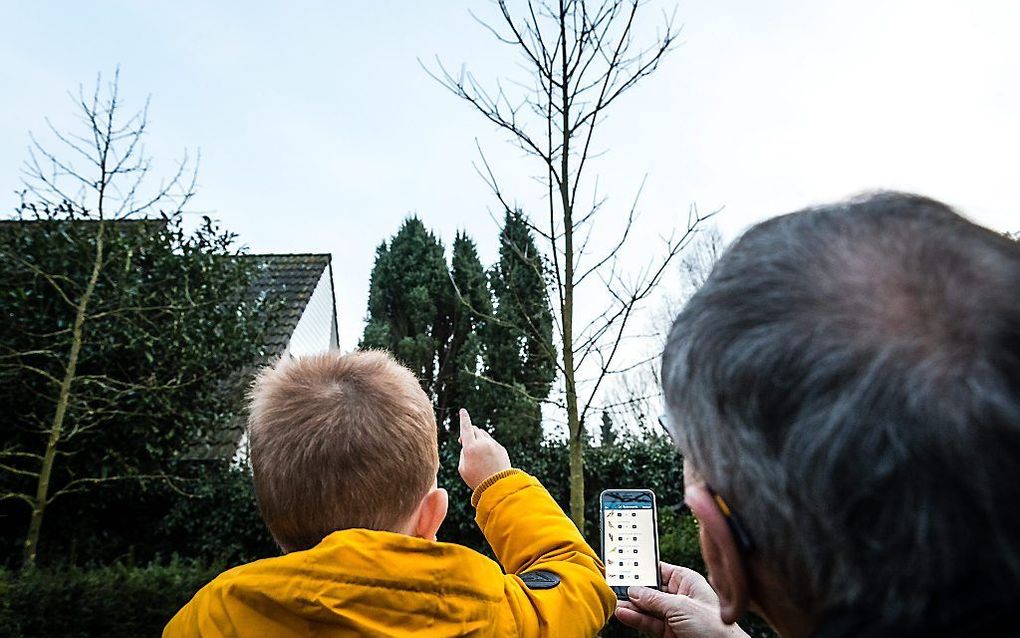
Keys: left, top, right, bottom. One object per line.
{"left": 359, "top": 216, "right": 455, "bottom": 402}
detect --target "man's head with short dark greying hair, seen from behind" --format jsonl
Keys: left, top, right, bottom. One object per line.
{"left": 662, "top": 193, "right": 1020, "bottom": 624}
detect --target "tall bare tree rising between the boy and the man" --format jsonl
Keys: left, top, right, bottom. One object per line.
{"left": 426, "top": 0, "right": 703, "bottom": 529}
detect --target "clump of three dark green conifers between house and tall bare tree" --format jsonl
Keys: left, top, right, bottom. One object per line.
{"left": 360, "top": 211, "right": 556, "bottom": 449}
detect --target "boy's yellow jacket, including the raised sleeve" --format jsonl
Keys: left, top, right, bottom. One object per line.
{"left": 163, "top": 471, "right": 616, "bottom": 638}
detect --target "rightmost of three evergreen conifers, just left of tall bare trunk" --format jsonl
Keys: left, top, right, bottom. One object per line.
{"left": 482, "top": 210, "right": 556, "bottom": 449}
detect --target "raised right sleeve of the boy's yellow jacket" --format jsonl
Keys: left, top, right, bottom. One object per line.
{"left": 475, "top": 471, "right": 616, "bottom": 638}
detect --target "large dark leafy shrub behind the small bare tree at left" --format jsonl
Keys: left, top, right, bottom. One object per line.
{"left": 0, "top": 205, "right": 275, "bottom": 566}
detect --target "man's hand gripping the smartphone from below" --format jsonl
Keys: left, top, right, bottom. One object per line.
{"left": 616, "top": 562, "right": 747, "bottom": 638}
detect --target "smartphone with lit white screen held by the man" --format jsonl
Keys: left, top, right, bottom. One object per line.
{"left": 599, "top": 490, "right": 662, "bottom": 600}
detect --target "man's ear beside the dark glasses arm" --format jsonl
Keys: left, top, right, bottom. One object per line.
{"left": 683, "top": 484, "right": 750, "bottom": 624}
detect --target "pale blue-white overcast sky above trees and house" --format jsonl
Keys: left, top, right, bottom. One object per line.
{"left": 0, "top": 0, "right": 1020, "bottom": 348}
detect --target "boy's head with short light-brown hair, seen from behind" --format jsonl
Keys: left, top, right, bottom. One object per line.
{"left": 248, "top": 351, "right": 447, "bottom": 551}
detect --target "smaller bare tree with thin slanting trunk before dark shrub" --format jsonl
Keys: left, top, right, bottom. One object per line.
{"left": 0, "top": 75, "right": 197, "bottom": 567}
